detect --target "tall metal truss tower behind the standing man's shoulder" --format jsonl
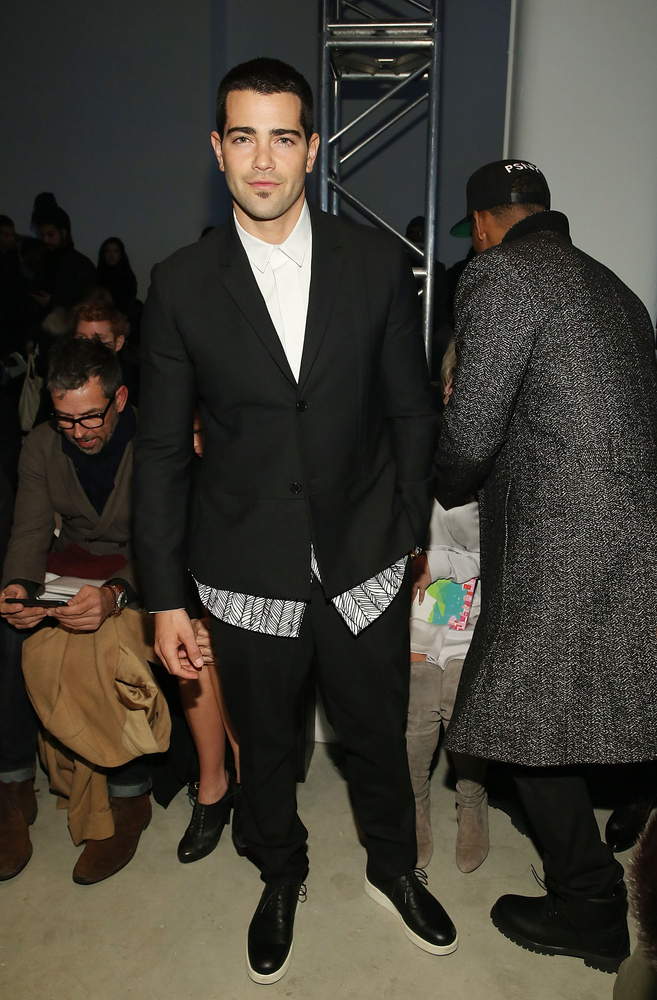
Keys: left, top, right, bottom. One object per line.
{"left": 319, "top": 0, "right": 442, "bottom": 364}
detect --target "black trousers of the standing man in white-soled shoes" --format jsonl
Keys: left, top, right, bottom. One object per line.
{"left": 212, "top": 572, "right": 417, "bottom": 882}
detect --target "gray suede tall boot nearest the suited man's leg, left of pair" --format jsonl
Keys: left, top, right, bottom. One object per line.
{"left": 406, "top": 660, "right": 443, "bottom": 868}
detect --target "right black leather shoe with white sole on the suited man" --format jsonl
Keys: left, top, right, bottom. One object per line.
{"left": 365, "top": 868, "right": 459, "bottom": 955}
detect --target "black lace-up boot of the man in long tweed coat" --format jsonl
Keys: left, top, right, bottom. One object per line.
{"left": 490, "top": 880, "right": 630, "bottom": 972}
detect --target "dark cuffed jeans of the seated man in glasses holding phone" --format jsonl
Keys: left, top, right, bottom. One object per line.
{"left": 0, "top": 618, "right": 152, "bottom": 794}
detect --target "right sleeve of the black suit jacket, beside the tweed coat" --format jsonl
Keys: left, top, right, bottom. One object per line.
{"left": 381, "top": 246, "right": 438, "bottom": 545}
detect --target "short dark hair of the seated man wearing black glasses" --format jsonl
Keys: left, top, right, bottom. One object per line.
{"left": 47, "top": 335, "right": 123, "bottom": 399}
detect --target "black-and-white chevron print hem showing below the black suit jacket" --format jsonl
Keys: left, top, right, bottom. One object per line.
{"left": 196, "top": 548, "right": 410, "bottom": 639}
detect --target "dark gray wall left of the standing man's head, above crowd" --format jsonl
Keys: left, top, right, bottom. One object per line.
{"left": 0, "top": 0, "right": 215, "bottom": 297}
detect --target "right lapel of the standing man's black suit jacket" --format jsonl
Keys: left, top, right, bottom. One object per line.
{"left": 299, "top": 206, "right": 344, "bottom": 390}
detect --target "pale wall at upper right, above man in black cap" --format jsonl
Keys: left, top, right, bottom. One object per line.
{"left": 507, "top": 0, "right": 657, "bottom": 320}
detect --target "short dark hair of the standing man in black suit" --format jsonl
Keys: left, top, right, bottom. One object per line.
{"left": 217, "top": 57, "right": 315, "bottom": 142}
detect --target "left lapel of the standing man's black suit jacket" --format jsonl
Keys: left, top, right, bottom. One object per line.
{"left": 219, "top": 221, "right": 296, "bottom": 385}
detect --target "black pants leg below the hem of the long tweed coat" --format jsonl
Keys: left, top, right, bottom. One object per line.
{"left": 514, "top": 767, "right": 623, "bottom": 899}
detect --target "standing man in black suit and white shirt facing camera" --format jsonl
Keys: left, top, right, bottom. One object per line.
{"left": 131, "top": 59, "right": 457, "bottom": 983}
